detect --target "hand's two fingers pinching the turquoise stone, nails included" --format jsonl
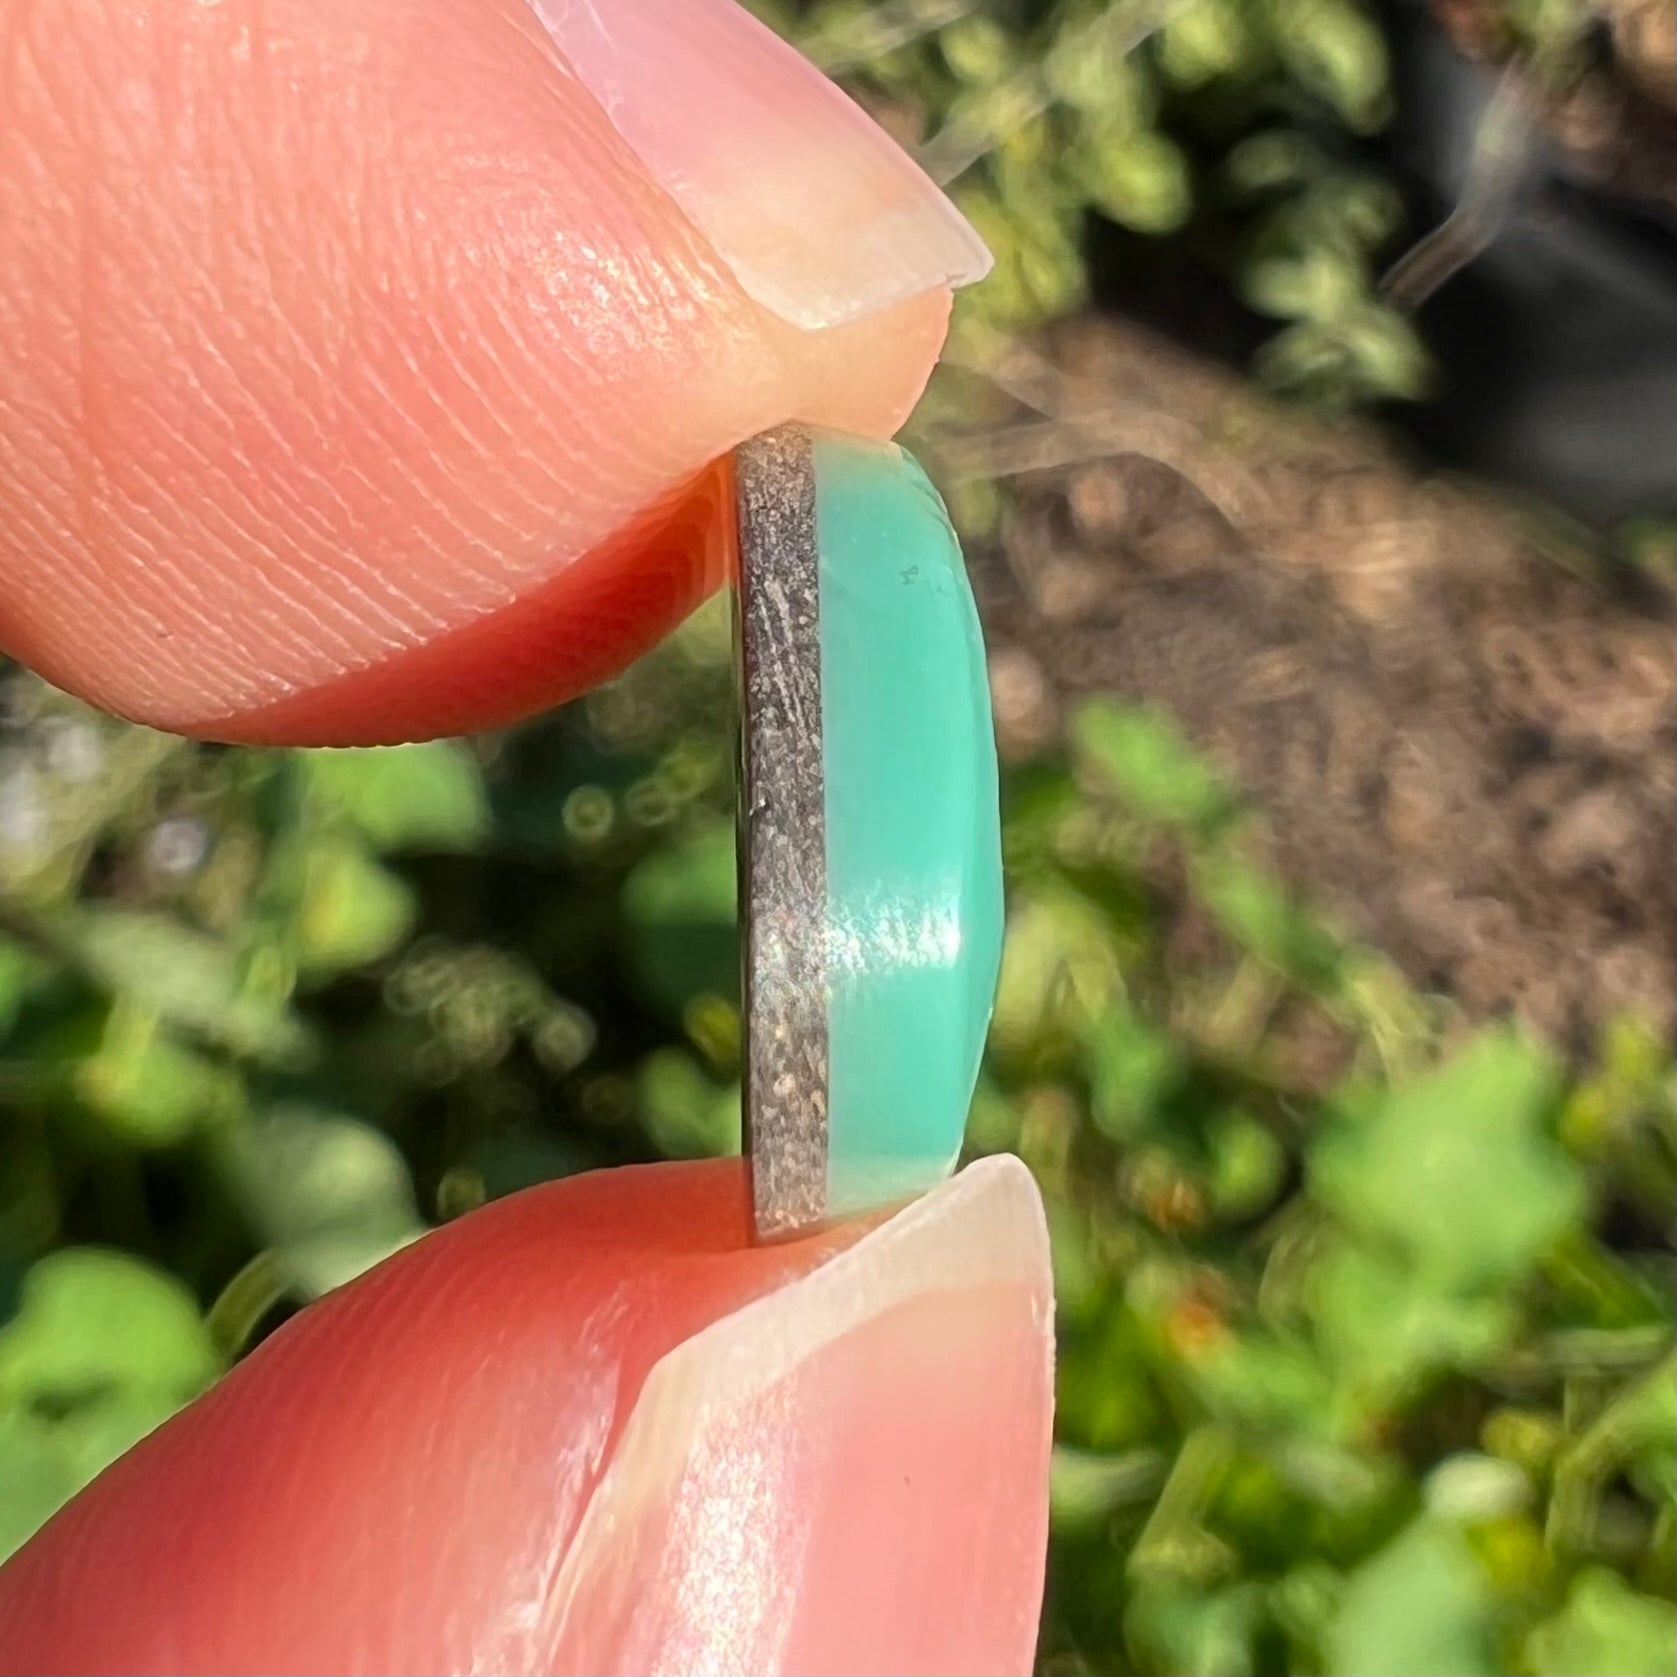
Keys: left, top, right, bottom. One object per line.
{"left": 0, "top": 0, "right": 1050, "bottom": 1672}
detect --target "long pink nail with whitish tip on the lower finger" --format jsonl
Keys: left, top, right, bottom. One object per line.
{"left": 548, "top": 1159, "right": 1051, "bottom": 1674}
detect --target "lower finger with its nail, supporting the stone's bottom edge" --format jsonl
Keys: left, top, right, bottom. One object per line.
{"left": 0, "top": 1159, "right": 1051, "bottom": 1674}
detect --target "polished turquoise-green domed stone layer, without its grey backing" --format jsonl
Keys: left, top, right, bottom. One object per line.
{"left": 813, "top": 433, "right": 1003, "bottom": 1216}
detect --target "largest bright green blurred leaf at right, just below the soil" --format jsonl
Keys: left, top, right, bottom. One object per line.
{"left": 1311, "top": 1031, "right": 1585, "bottom": 1293}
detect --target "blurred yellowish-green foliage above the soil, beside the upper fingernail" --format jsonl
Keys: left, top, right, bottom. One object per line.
{"left": 753, "top": 0, "right": 1428, "bottom": 404}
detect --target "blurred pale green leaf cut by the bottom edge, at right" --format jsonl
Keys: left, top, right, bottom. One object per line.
{"left": 1323, "top": 1518, "right": 1498, "bottom": 1677}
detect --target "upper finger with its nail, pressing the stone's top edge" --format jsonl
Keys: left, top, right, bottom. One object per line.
{"left": 0, "top": 0, "right": 986, "bottom": 743}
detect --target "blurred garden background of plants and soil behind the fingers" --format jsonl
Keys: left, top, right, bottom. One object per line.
{"left": 0, "top": 0, "right": 1677, "bottom": 1677}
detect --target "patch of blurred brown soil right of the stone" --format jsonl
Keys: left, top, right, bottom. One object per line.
{"left": 936, "top": 320, "right": 1677, "bottom": 1045}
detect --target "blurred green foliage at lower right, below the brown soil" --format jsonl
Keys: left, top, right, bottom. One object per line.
{"left": 974, "top": 704, "right": 1677, "bottom": 1674}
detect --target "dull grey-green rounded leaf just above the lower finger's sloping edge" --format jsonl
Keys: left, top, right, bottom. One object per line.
{"left": 221, "top": 1103, "right": 424, "bottom": 1298}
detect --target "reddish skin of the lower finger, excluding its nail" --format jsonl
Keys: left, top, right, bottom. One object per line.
{"left": 0, "top": 1160, "right": 844, "bottom": 1674}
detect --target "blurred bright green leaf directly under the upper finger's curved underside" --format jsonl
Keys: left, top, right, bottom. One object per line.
{"left": 295, "top": 740, "right": 490, "bottom": 850}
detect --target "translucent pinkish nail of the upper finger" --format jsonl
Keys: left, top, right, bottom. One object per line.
{"left": 530, "top": 0, "right": 991, "bottom": 329}
